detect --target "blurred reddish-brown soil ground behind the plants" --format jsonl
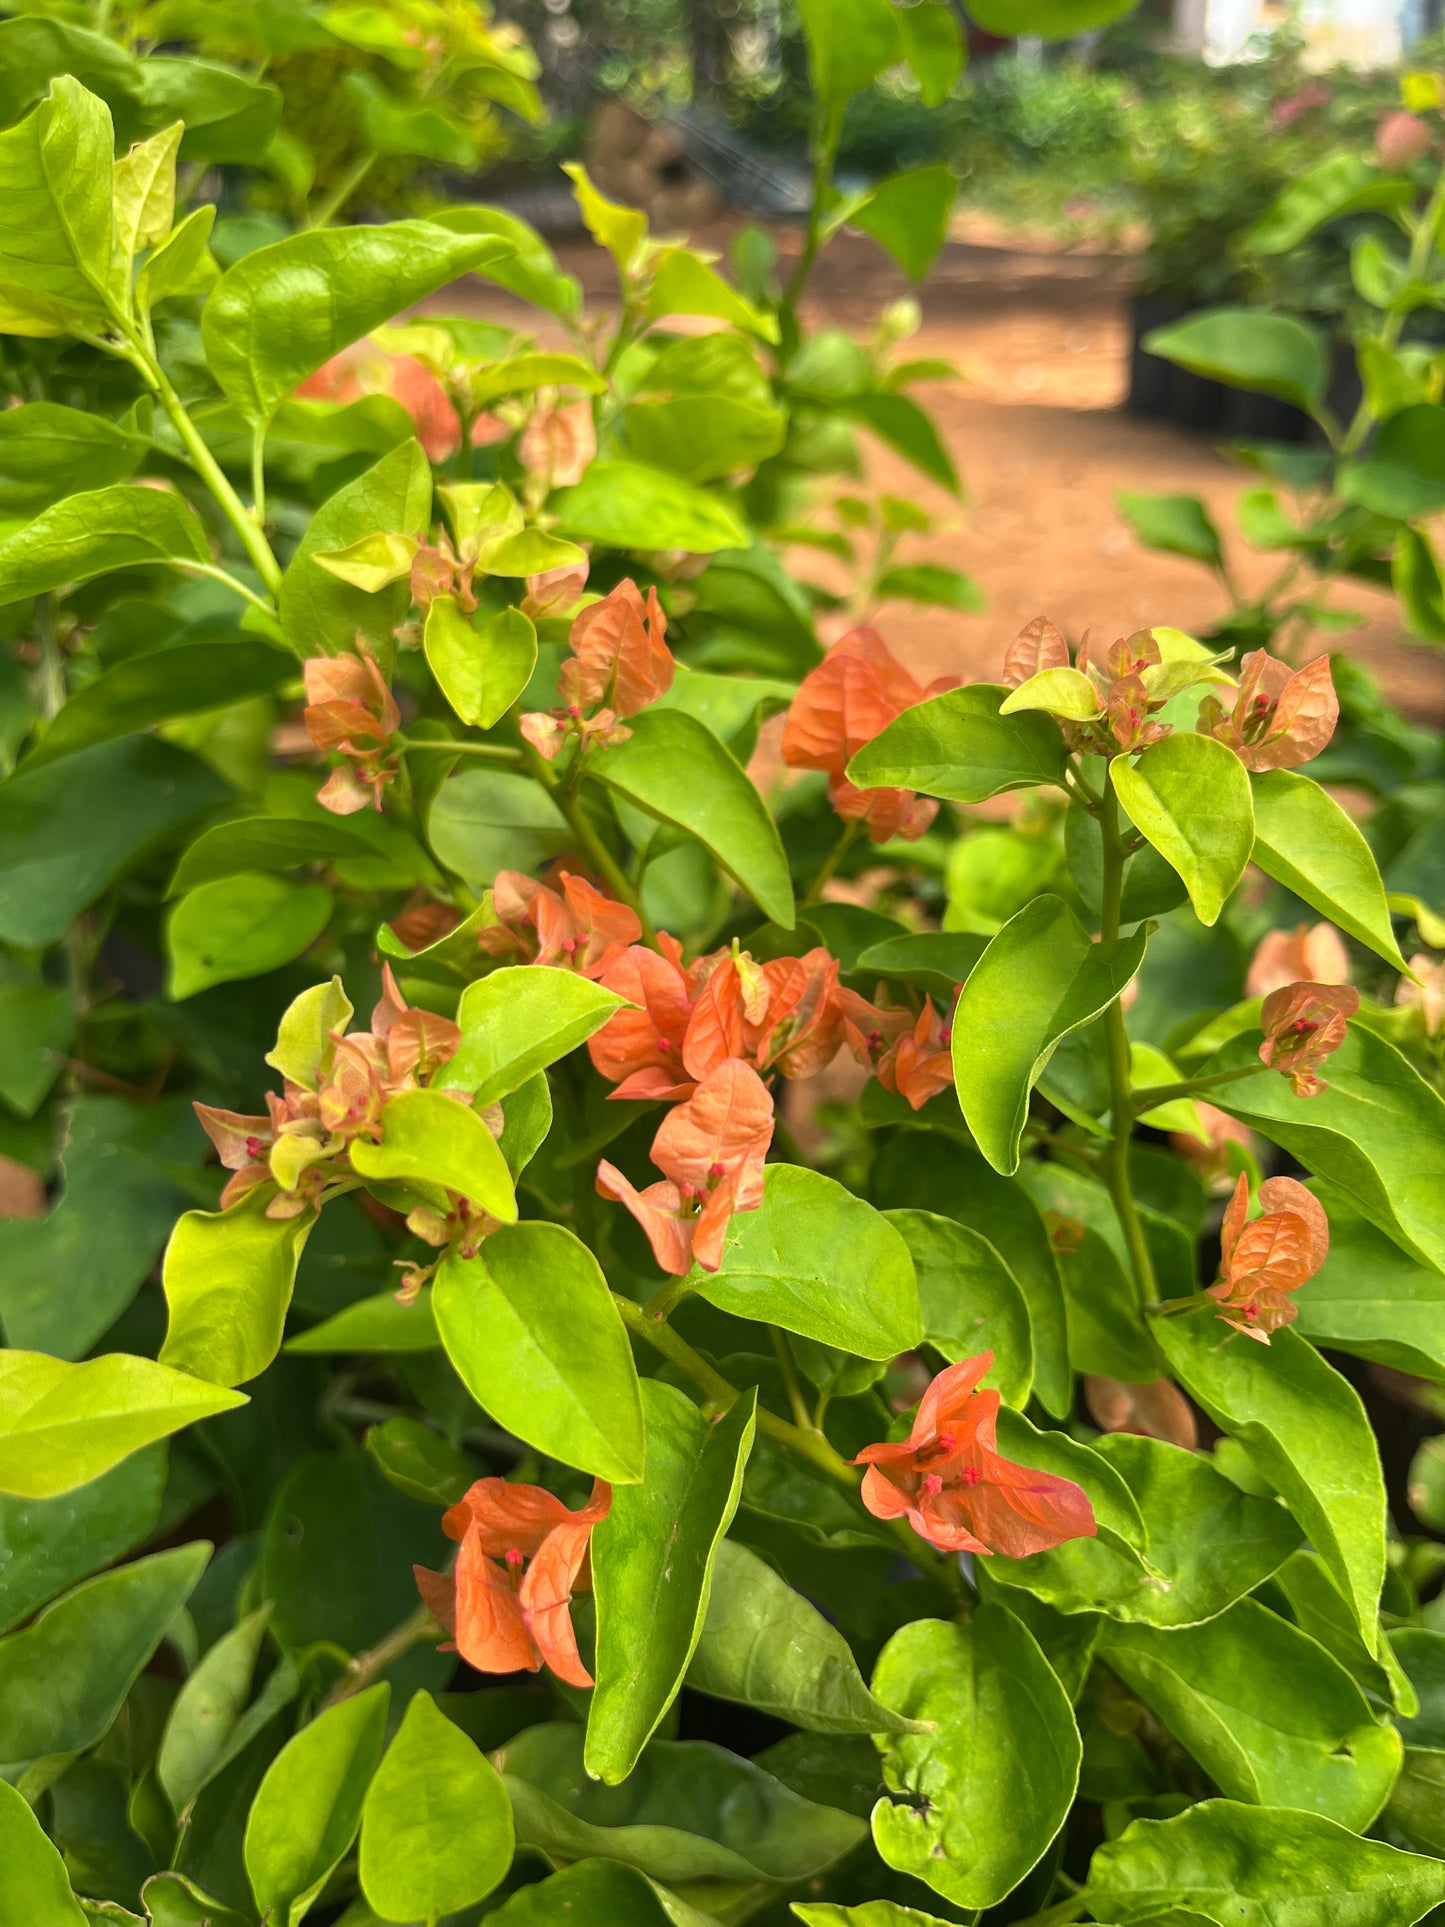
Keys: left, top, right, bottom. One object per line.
{"left": 453, "top": 212, "right": 1445, "bottom": 725}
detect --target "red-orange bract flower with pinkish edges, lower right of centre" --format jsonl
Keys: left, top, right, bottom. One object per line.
{"left": 854, "top": 1351, "right": 1098, "bottom": 1559}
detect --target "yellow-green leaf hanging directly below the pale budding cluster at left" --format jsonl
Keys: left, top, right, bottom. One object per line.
{"left": 160, "top": 1185, "right": 316, "bottom": 1386}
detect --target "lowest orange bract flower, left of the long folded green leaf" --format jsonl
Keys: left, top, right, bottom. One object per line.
{"left": 412, "top": 1478, "right": 613, "bottom": 1686}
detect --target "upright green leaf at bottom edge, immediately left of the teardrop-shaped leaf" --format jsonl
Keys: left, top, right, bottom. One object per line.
{"left": 245, "top": 1680, "right": 391, "bottom": 1927}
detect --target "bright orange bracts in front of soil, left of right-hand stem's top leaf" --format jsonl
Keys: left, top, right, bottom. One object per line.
{"left": 782, "top": 628, "right": 958, "bottom": 842}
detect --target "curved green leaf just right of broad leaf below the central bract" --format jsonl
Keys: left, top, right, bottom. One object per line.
{"left": 888, "top": 1210, "right": 1033, "bottom": 1407}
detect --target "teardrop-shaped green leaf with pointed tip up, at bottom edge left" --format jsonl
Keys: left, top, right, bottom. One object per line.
{"left": 360, "top": 1692, "right": 512, "bottom": 1921}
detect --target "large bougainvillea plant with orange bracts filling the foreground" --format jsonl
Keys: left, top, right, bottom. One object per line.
{"left": 0, "top": 0, "right": 1445, "bottom": 1927}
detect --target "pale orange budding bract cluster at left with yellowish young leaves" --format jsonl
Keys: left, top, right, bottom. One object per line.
{"left": 195, "top": 964, "right": 460, "bottom": 1218}
